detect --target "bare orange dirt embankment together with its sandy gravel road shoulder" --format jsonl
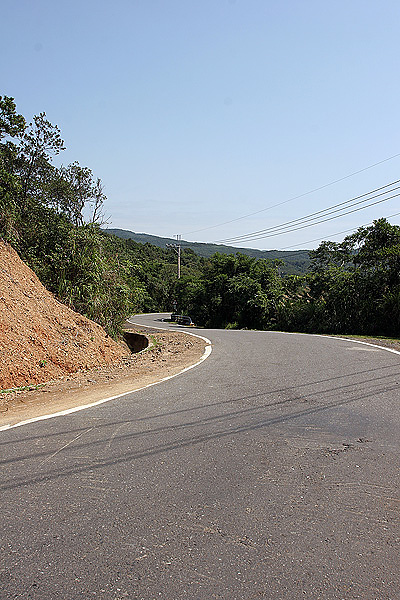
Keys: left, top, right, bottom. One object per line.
{"left": 0, "top": 240, "right": 205, "bottom": 425}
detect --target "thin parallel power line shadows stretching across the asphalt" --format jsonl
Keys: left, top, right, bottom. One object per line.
{"left": 0, "top": 364, "right": 398, "bottom": 490}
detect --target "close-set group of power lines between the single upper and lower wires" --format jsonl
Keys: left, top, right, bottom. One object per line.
{"left": 217, "top": 180, "right": 400, "bottom": 243}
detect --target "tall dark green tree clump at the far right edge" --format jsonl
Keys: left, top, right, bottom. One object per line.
{"left": 301, "top": 219, "right": 400, "bottom": 336}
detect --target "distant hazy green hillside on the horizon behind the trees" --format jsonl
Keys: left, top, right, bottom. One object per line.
{"left": 104, "top": 229, "right": 310, "bottom": 274}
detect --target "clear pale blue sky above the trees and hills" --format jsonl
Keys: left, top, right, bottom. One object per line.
{"left": 0, "top": 0, "right": 400, "bottom": 249}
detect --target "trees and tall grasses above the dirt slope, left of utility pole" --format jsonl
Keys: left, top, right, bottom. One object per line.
{"left": 0, "top": 96, "right": 203, "bottom": 337}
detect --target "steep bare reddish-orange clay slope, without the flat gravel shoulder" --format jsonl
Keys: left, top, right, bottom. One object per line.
{"left": 0, "top": 240, "right": 129, "bottom": 390}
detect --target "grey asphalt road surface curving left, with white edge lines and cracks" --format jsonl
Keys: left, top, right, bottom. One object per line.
{"left": 0, "top": 316, "right": 400, "bottom": 600}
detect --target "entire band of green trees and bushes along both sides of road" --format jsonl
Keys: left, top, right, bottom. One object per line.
{"left": 0, "top": 96, "right": 400, "bottom": 337}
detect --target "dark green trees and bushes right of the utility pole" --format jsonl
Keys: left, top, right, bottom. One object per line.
{"left": 177, "top": 219, "right": 400, "bottom": 337}
